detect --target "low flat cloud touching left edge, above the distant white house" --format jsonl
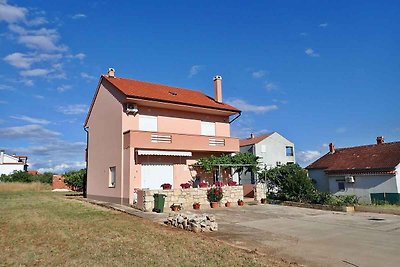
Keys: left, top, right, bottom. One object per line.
{"left": 0, "top": 124, "right": 61, "bottom": 140}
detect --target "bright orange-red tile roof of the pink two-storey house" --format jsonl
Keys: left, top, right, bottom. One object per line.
{"left": 102, "top": 75, "right": 240, "bottom": 113}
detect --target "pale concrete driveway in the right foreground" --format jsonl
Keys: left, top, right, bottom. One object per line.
{"left": 197, "top": 205, "right": 400, "bottom": 266}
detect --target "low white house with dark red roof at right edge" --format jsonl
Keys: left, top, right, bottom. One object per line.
{"left": 306, "top": 136, "right": 400, "bottom": 203}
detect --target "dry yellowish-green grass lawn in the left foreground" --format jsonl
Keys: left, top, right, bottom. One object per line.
{"left": 0, "top": 187, "right": 286, "bottom": 266}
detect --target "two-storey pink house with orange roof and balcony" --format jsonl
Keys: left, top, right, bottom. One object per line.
{"left": 85, "top": 69, "right": 240, "bottom": 204}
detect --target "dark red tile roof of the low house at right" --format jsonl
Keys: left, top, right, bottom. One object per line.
{"left": 306, "top": 142, "right": 400, "bottom": 174}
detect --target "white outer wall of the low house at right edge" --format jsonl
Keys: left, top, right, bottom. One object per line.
{"left": 327, "top": 175, "right": 399, "bottom": 203}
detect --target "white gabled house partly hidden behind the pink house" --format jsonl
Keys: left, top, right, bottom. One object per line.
{"left": 240, "top": 132, "right": 296, "bottom": 184}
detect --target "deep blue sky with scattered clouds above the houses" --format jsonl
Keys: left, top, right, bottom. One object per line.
{"left": 0, "top": 0, "right": 400, "bottom": 172}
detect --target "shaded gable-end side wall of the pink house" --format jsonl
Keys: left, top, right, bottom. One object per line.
{"left": 87, "top": 81, "right": 129, "bottom": 203}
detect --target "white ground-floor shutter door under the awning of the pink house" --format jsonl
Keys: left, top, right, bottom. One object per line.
{"left": 141, "top": 164, "right": 174, "bottom": 189}
